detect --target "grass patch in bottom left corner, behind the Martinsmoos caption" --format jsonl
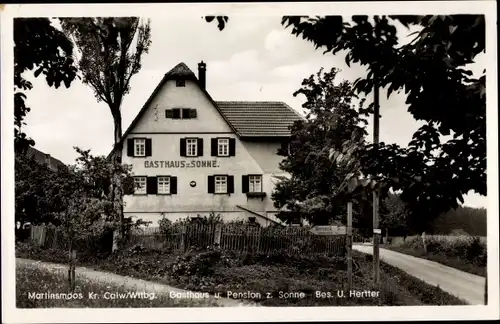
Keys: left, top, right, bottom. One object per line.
{"left": 16, "top": 265, "right": 211, "bottom": 308}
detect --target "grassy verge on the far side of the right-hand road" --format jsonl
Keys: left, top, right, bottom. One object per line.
{"left": 384, "top": 235, "right": 487, "bottom": 277}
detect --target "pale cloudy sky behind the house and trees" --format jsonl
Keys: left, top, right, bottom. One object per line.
{"left": 23, "top": 15, "right": 487, "bottom": 207}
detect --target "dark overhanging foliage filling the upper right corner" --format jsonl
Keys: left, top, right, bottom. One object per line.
{"left": 282, "top": 15, "right": 486, "bottom": 231}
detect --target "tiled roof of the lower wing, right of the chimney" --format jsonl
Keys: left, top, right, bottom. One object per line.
{"left": 217, "top": 101, "right": 304, "bottom": 137}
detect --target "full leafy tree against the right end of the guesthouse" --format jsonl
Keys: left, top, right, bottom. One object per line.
{"left": 272, "top": 68, "right": 369, "bottom": 226}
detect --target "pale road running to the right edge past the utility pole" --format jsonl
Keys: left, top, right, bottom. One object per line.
{"left": 353, "top": 244, "right": 485, "bottom": 305}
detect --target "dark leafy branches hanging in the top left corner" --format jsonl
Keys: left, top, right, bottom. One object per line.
{"left": 14, "top": 18, "right": 76, "bottom": 152}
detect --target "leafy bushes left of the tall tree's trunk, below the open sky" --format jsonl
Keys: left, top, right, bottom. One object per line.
{"left": 16, "top": 147, "right": 138, "bottom": 253}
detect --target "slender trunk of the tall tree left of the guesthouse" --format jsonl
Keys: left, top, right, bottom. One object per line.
{"left": 111, "top": 113, "right": 125, "bottom": 251}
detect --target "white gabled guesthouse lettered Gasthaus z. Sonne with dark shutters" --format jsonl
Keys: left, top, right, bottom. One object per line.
{"left": 116, "top": 62, "right": 302, "bottom": 226}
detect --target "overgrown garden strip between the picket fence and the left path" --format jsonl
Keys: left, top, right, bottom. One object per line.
{"left": 16, "top": 235, "right": 465, "bottom": 307}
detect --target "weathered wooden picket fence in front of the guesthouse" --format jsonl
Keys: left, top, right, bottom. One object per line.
{"left": 128, "top": 223, "right": 346, "bottom": 255}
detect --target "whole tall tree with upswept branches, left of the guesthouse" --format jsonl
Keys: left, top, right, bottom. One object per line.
{"left": 61, "top": 17, "right": 151, "bottom": 248}
